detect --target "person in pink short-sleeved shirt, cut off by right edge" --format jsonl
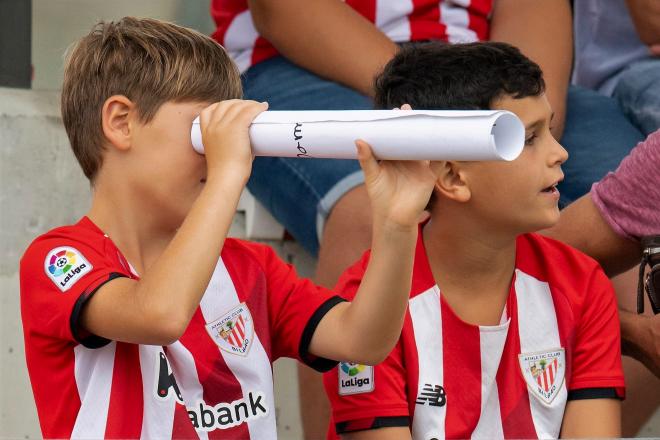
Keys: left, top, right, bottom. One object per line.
{"left": 544, "top": 130, "right": 660, "bottom": 437}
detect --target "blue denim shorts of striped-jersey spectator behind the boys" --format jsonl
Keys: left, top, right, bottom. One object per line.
{"left": 243, "top": 56, "right": 643, "bottom": 255}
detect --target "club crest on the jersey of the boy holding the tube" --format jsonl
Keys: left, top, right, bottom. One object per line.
{"left": 206, "top": 303, "right": 254, "bottom": 356}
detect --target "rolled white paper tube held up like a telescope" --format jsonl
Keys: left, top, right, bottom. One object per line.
{"left": 191, "top": 110, "right": 525, "bottom": 160}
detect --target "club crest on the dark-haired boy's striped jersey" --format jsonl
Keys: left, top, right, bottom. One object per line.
{"left": 518, "top": 348, "right": 566, "bottom": 404}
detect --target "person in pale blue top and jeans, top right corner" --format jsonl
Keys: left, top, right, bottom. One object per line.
{"left": 572, "top": 0, "right": 660, "bottom": 135}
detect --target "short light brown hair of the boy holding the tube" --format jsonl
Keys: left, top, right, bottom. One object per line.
{"left": 61, "top": 17, "right": 242, "bottom": 182}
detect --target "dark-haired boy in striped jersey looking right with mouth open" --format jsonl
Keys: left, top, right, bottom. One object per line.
{"left": 324, "top": 43, "right": 624, "bottom": 440}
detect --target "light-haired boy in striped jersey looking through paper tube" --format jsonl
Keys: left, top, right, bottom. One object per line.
{"left": 20, "top": 18, "right": 435, "bottom": 439}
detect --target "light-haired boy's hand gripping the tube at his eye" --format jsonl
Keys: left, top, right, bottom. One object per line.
{"left": 199, "top": 99, "right": 268, "bottom": 184}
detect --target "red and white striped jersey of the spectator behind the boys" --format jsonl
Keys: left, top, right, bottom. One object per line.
{"left": 211, "top": 0, "right": 493, "bottom": 72}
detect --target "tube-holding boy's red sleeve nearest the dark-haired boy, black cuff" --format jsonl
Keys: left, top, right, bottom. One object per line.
{"left": 251, "top": 242, "right": 344, "bottom": 371}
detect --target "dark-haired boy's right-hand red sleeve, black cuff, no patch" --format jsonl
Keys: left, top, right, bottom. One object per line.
{"left": 568, "top": 268, "right": 625, "bottom": 400}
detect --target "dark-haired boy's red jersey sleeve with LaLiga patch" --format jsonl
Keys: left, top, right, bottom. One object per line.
{"left": 323, "top": 252, "right": 410, "bottom": 434}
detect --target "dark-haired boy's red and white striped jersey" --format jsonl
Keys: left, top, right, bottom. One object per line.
{"left": 324, "top": 229, "right": 624, "bottom": 440}
